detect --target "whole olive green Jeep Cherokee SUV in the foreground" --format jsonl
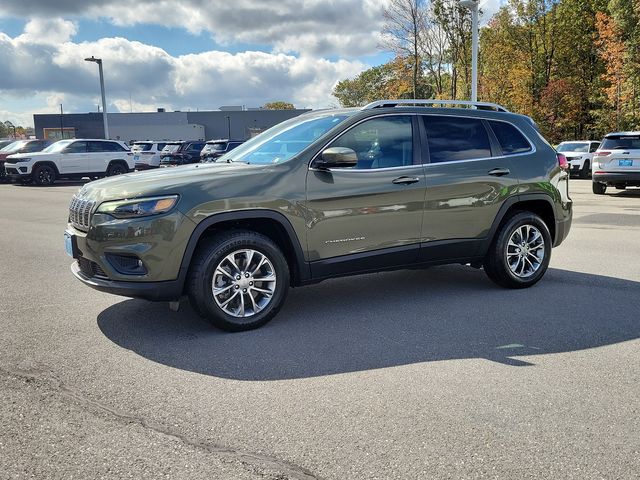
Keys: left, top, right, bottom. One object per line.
{"left": 65, "top": 100, "right": 572, "bottom": 331}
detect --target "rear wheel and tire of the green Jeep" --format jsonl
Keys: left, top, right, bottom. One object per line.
{"left": 483, "top": 212, "right": 552, "bottom": 288}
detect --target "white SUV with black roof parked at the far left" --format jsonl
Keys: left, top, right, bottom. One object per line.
{"left": 4, "top": 139, "right": 134, "bottom": 185}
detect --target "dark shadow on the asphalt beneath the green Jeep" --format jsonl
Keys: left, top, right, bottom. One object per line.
{"left": 98, "top": 266, "right": 640, "bottom": 380}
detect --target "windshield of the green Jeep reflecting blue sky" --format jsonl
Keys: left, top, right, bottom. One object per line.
{"left": 218, "top": 113, "right": 349, "bottom": 165}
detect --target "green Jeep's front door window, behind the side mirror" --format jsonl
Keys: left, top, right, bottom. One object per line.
{"left": 329, "top": 115, "right": 413, "bottom": 170}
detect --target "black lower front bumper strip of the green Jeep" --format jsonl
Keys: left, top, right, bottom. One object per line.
{"left": 71, "top": 262, "right": 182, "bottom": 301}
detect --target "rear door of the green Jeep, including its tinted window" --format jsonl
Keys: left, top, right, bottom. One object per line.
{"left": 420, "top": 115, "right": 520, "bottom": 260}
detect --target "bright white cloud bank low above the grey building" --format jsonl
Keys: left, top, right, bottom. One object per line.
{"left": 0, "top": 18, "right": 366, "bottom": 124}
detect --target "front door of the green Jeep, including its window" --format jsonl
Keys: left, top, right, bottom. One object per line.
{"left": 306, "top": 115, "right": 425, "bottom": 277}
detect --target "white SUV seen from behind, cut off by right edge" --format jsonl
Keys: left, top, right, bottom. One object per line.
{"left": 592, "top": 132, "right": 640, "bottom": 195}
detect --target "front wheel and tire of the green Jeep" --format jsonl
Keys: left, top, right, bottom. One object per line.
{"left": 187, "top": 230, "right": 289, "bottom": 332}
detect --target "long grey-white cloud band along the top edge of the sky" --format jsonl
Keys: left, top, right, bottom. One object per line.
{"left": 0, "top": 0, "right": 387, "bottom": 57}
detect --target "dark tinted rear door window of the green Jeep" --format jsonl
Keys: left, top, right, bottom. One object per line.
{"left": 422, "top": 115, "right": 491, "bottom": 163}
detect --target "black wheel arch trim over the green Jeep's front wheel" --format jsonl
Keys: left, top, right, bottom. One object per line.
{"left": 180, "top": 209, "right": 310, "bottom": 286}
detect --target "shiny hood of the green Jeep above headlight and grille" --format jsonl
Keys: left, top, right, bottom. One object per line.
{"left": 78, "top": 163, "right": 260, "bottom": 202}
